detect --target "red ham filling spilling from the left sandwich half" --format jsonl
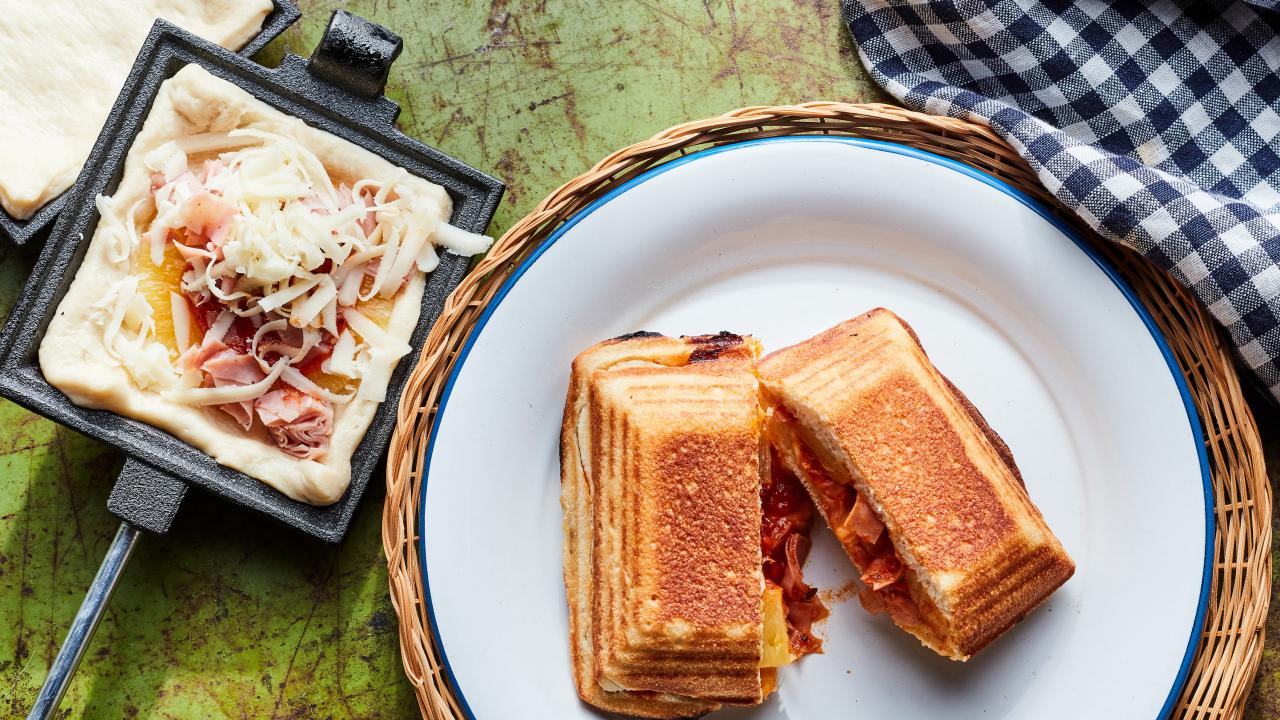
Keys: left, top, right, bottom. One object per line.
{"left": 760, "top": 448, "right": 827, "bottom": 660}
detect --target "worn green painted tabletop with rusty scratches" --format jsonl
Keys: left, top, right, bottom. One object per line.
{"left": 0, "top": 0, "right": 1280, "bottom": 719}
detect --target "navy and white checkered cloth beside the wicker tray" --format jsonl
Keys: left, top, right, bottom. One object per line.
{"left": 844, "top": 0, "right": 1280, "bottom": 400}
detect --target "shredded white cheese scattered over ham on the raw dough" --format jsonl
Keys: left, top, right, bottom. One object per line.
{"left": 117, "top": 128, "right": 493, "bottom": 405}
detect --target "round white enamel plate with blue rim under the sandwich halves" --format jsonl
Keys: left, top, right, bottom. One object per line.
{"left": 421, "top": 138, "right": 1212, "bottom": 720}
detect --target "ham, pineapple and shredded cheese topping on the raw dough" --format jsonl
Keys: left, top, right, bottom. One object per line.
{"left": 99, "top": 128, "right": 492, "bottom": 460}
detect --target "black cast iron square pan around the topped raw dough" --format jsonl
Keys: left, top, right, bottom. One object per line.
{"left": 0, "top": 10, "right": 503, "bottom": 542}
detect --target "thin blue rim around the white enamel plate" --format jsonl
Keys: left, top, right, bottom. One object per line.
{"left": 417, "top": 136, "right": 1215, "bottom": 720}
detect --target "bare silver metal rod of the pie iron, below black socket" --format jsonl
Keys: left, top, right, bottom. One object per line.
{"left": 27, "top": 523, "right": 140, "bottom": 720}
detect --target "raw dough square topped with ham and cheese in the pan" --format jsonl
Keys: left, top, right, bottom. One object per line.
{"left": 40, "top": 65, "right": 489, "bottom": 505}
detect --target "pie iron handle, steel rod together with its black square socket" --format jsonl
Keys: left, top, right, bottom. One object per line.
{"left": 27, "top": 457, "right": 187, "bottom": 720}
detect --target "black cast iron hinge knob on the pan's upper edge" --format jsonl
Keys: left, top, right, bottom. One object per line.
{"left": 307, "top": 10, "right": 404, "bottom": 100}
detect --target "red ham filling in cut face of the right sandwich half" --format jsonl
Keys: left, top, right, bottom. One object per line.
{"left": 771, "top": 407, "right": 925, "bottom": 628}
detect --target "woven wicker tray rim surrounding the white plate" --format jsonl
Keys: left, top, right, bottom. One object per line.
{"left": 383, "top": 102, "right": 1271, "bottom": 720}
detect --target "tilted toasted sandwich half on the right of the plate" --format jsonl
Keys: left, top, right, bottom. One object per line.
{"left": 758, "top": 309, "right": 1075, "bottom": 660}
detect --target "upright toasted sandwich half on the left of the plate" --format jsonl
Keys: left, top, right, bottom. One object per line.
{"left": 561, "top": 333, "right": 820, "bottom": 717}
